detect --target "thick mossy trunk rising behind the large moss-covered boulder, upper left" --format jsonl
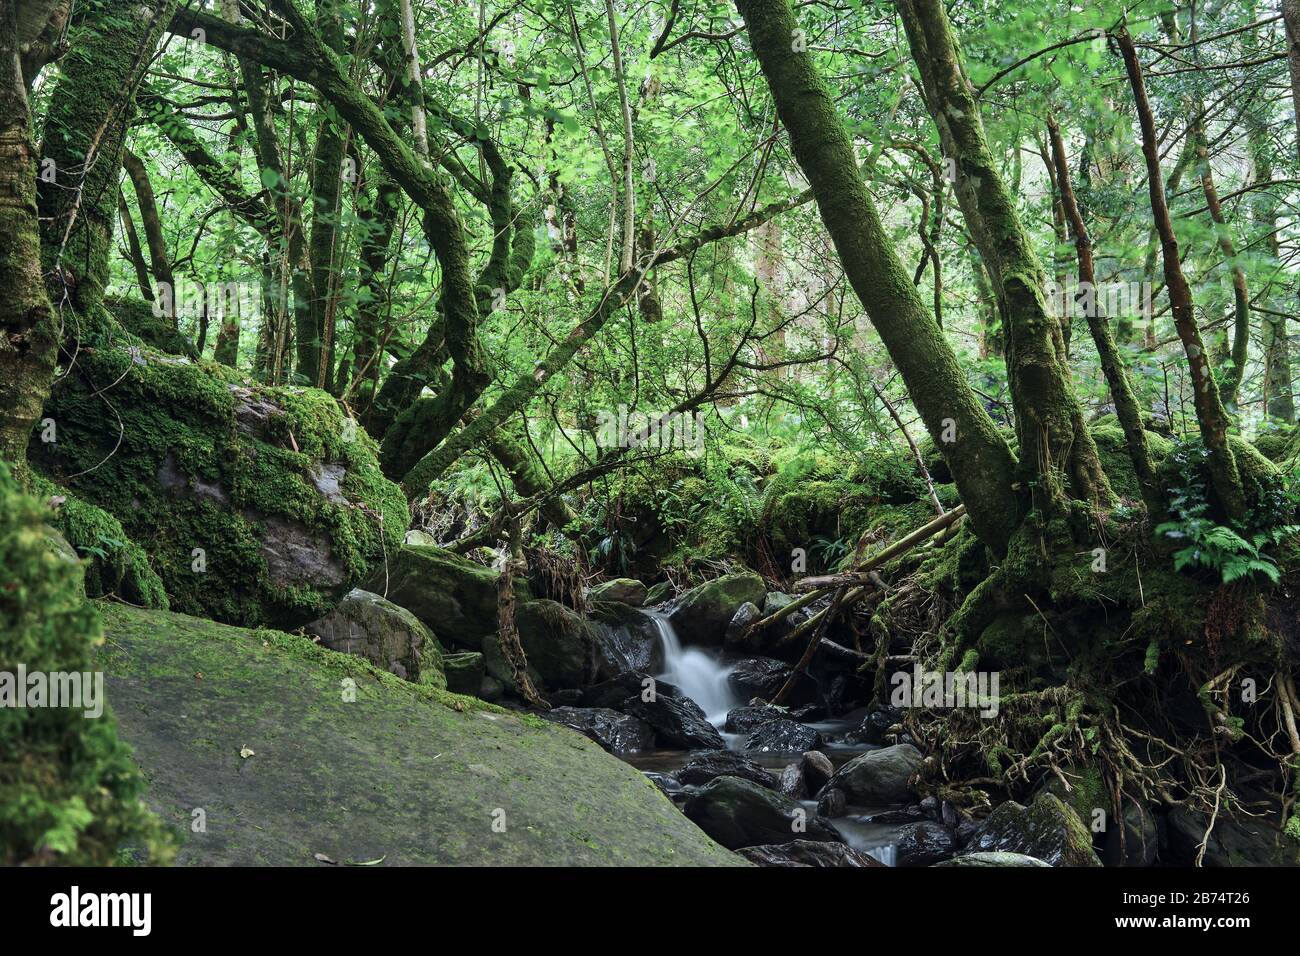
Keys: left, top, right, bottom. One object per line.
{"left": 36, "top": 0, "right": 176, "bottom": 325}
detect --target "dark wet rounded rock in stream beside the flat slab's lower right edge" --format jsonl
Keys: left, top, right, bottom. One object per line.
{"left": 683, "top": 777, "right": 842, "bottom": 849}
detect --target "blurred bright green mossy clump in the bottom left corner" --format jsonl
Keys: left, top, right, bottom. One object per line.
{"left": 0, "top": 462, "right": 169, "bottom": 866}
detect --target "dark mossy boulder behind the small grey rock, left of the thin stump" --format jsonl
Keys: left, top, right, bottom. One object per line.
{"left": 361, "top": 545, "right": 512, "bottom": 650}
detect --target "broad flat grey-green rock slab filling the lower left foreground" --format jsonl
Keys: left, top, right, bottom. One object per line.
{"left": 99, "top": 605, "right": 740, "bottom": 866}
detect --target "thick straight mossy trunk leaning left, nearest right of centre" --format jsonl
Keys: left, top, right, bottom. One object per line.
{"left": 736, "top": 0, "right": 1023, "bottom": 550}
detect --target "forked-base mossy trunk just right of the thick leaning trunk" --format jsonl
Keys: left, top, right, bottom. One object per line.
{"left": 897, "top": 0, "right": 1114, "bottom": 512}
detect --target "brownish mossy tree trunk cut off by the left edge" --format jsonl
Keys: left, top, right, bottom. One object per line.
{"left": 0, "top": 0, "right": 59, "bottom": 464}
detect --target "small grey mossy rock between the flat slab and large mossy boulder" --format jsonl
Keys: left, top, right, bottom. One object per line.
{"left": 303, "top": 588, "right": 447, "bottom": 687}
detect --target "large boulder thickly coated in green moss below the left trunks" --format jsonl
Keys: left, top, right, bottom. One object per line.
{"left": 29, "top": 345, "right": 407, "bottom": 627}
